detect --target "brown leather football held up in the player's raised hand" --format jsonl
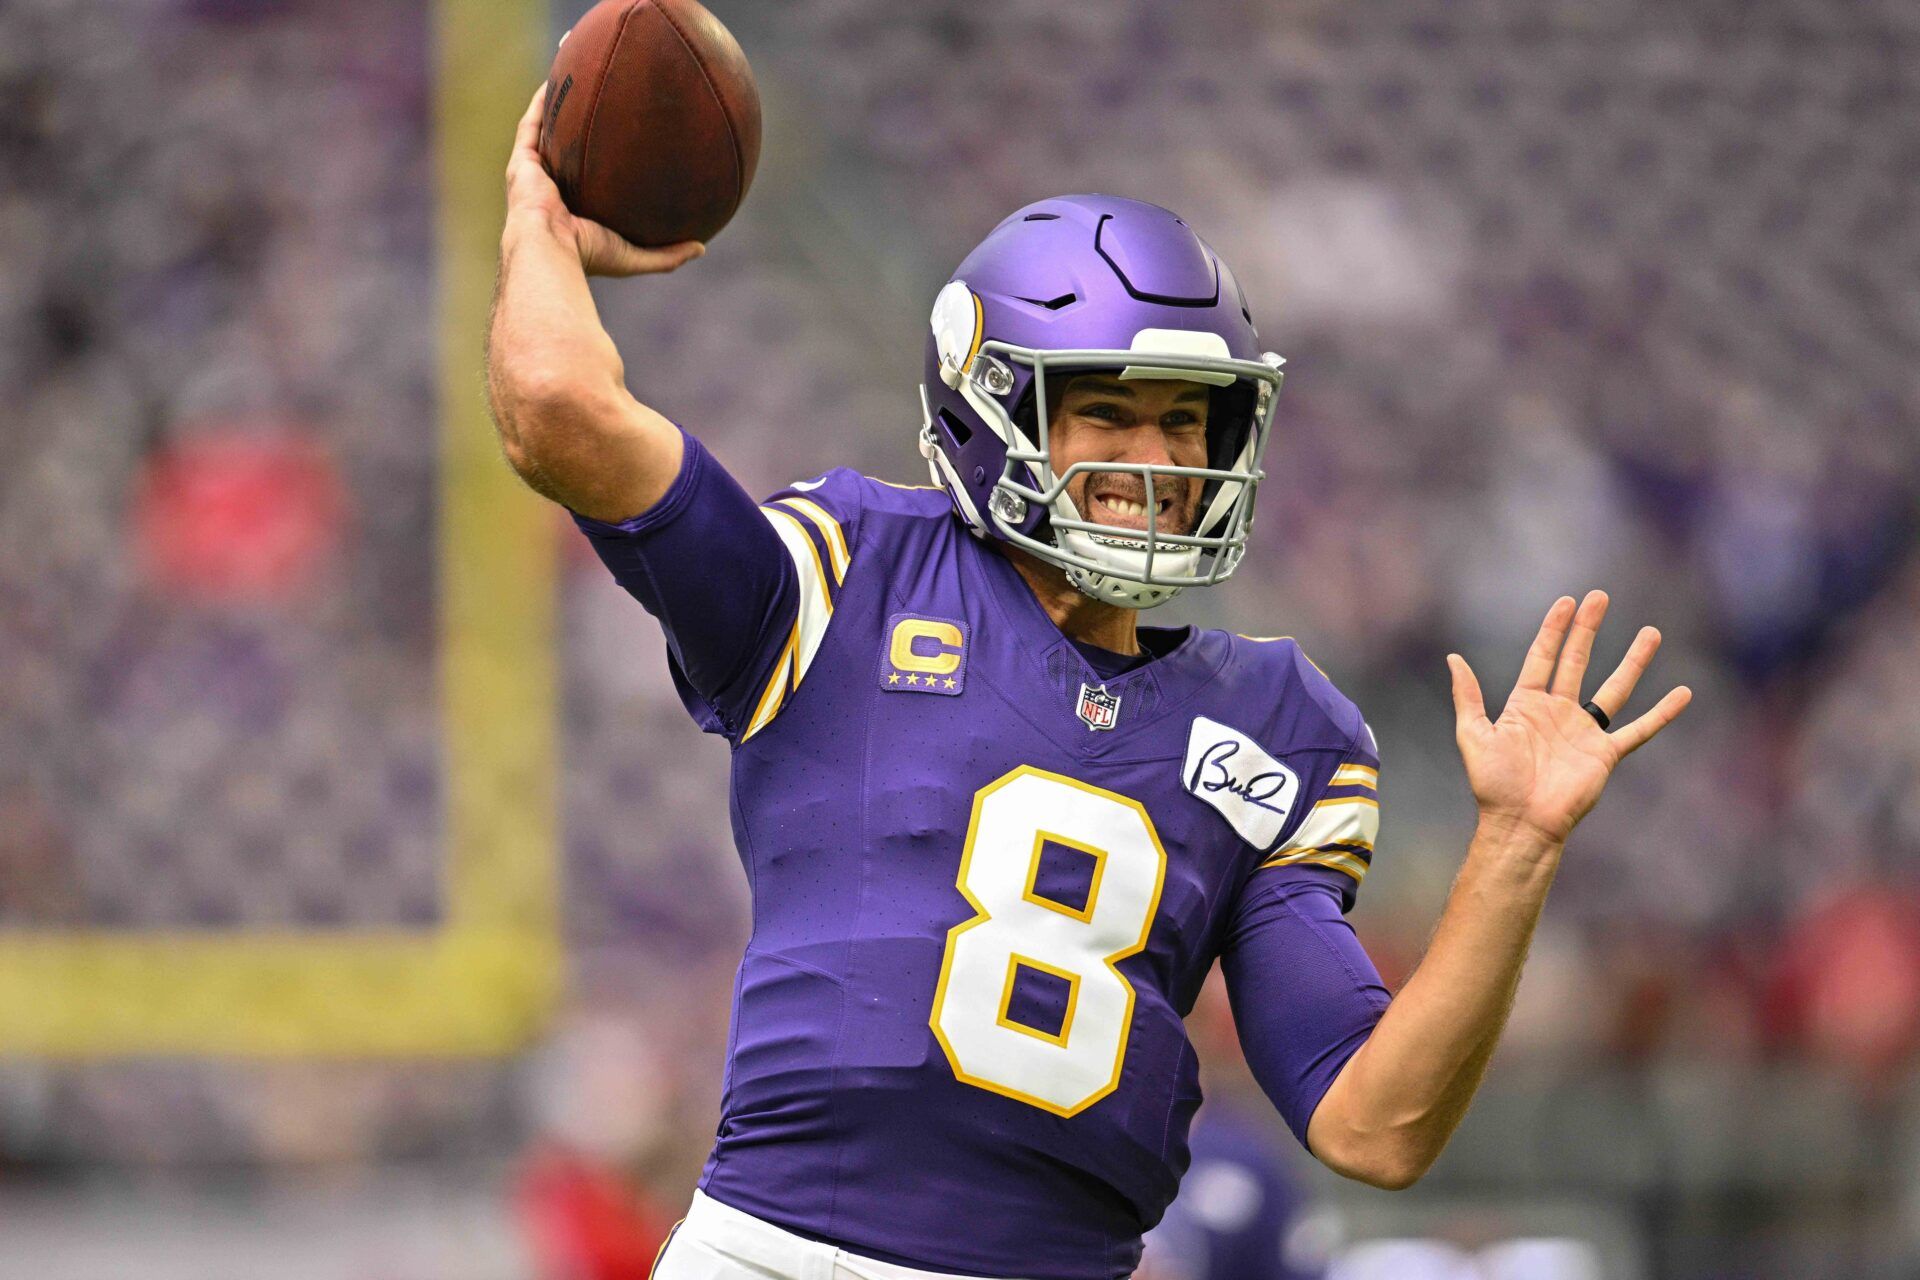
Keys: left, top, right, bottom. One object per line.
{"left": 540, "top": 0, "right": 760, "bottom": 246}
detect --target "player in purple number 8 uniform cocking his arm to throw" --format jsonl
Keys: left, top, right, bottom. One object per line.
{"left": 488, "top": 96, "right": 1690, "bottom": 1280}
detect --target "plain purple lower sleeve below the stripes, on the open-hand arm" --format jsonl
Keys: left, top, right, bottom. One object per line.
{"left": 1221, "top": 873, "right": 1390, "bottom": 1146}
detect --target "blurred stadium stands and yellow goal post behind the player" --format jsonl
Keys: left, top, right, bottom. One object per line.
{"left": 0, "top": 0, "right": 1920, "bottom": 1280}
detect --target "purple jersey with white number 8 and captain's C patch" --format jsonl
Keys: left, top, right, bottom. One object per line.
{"left": 578, "top": 438, "right": 1386, "bottom": 1280}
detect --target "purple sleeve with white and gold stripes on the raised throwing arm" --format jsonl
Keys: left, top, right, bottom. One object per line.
{"left": 574, "top": 436, "right": 860, "bottom": 745}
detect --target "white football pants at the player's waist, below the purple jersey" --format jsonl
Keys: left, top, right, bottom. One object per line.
{"left": 651, "top": 1192, "right": 1029, "bottom": 1280}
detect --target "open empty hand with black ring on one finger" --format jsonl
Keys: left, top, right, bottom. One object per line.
{"left": 1448, "top": 591, "right": 1693, "bottom": 842}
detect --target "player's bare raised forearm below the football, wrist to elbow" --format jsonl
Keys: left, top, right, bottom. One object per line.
{"left": 488, "top": 211, "right": 680, "bottom": 520}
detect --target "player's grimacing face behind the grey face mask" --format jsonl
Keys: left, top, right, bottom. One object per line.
{"left": 1048, "top": 374, "right": 1212, "bottom": 533}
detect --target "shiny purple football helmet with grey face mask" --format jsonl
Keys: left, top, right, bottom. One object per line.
{"left": 920, "top": 196, "right": 1283, "bottom": 608}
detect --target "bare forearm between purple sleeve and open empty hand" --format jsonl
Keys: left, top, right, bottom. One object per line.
{"left": 1308, "top": 819, "right": 1563, "bottom": 1186}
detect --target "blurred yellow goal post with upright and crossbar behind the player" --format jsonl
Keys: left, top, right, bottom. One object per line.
{"left": 0, "top": 0, "right": 563, "bottom": 1059}
